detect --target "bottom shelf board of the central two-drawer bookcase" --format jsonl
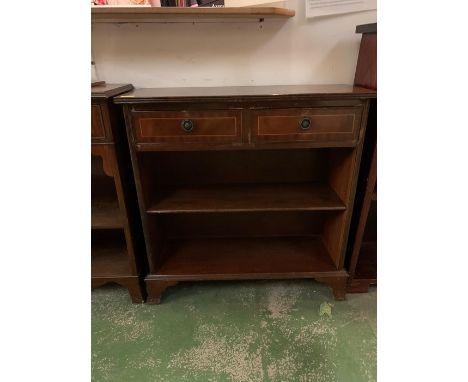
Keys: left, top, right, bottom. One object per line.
{"left": 154, "top": 236, "right": 340, "bottom": 280}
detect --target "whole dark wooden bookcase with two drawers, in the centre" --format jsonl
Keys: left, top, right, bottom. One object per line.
{"left": 114, "top": 85, "right": 375, "bottom": 303}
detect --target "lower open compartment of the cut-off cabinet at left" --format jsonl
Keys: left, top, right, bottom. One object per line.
{"left": 91, "top": 234, "right": 131, "bottom": 278}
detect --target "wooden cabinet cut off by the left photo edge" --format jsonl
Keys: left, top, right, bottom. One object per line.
{"left": 91, "top": 85, "right": 145, "bottom": 303}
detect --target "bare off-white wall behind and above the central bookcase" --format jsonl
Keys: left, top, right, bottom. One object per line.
{"left": 92, "top": 0, "right": 377, "bottom": 87}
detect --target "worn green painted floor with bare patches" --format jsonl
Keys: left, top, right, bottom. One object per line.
{"left": 92, "top": 280, "right": 377, "bottom": 382}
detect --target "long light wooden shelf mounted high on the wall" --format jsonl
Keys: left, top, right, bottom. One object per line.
{"left": 91, "top": 7, "right": 295, "bottom": 23}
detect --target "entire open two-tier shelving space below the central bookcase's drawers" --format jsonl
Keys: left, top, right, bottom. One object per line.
{"left": 136, "top": 147, "right": 354, "bottom": 281}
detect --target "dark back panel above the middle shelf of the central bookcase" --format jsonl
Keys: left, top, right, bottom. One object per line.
{"left": 139, "top": 149, "right": 327, "bottom": 185}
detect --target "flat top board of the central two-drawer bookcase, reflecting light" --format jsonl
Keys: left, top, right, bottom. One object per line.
{"left": 114, "top": 85, "right": 376, "bottom": 103}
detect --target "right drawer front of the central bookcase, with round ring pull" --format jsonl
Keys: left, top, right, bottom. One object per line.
{"left": 252, "top": 107, "right": 361, "bottom": 143}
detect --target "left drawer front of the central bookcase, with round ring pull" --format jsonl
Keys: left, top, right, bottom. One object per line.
{"left": 133, "top": 110, "right": 242, "bottom": 144}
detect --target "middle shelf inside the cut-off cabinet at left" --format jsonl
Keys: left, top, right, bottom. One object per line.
{"left": 91, "top": 197, "right": 123, "bottom": 229}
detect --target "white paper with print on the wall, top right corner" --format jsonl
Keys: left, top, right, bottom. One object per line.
{"left": 305, "top": 0, "right": 377, "bottom": 18}
